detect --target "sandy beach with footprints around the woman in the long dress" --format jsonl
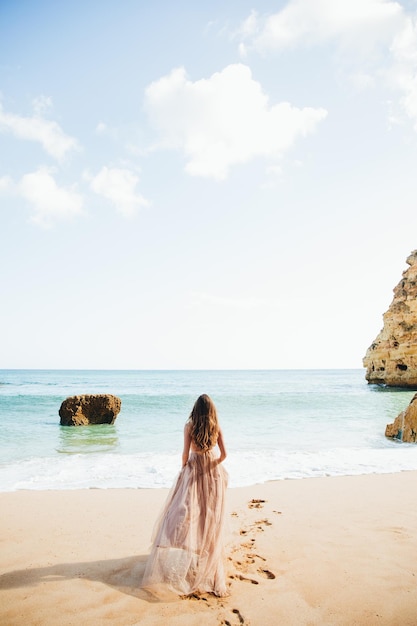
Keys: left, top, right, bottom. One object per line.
{"left": 0, "top": 472, "right": 417, "bottom": 626}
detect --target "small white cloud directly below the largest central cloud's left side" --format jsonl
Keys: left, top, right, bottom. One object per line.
{"left": 90, "top": 167, "right": 149, "bottom": 217}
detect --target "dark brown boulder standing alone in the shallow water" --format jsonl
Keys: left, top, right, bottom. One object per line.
{"left": 59, "top": 394, "right": 122, "bottom": 426}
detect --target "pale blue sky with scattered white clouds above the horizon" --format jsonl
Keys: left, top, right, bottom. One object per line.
{"left": 0, "top": 0, "right": 417, "bottom": 369}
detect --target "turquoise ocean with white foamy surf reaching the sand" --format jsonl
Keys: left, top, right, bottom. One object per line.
{"left": 0, "top": 370, "right": 417, "bottom": 492}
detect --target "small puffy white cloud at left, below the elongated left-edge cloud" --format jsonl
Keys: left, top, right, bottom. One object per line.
{"left": 17, "top": 167, "right": 83, "bottom": 226}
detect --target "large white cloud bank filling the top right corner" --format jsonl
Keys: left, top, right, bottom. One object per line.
{"left": 237, "top": 0, "right": 417, "bottom": 131}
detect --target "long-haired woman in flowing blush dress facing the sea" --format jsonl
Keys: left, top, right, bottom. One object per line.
{"left": 142, "top": 394, "right": 228, "bottom": 596}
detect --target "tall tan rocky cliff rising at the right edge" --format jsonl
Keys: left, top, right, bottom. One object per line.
{"left": 363, "top": 250, "right": 417, "bottom": 388}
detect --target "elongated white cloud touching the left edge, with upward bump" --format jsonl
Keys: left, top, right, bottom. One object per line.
{"left": 0, "top": 97, "right": 79, "bottom": 161}
